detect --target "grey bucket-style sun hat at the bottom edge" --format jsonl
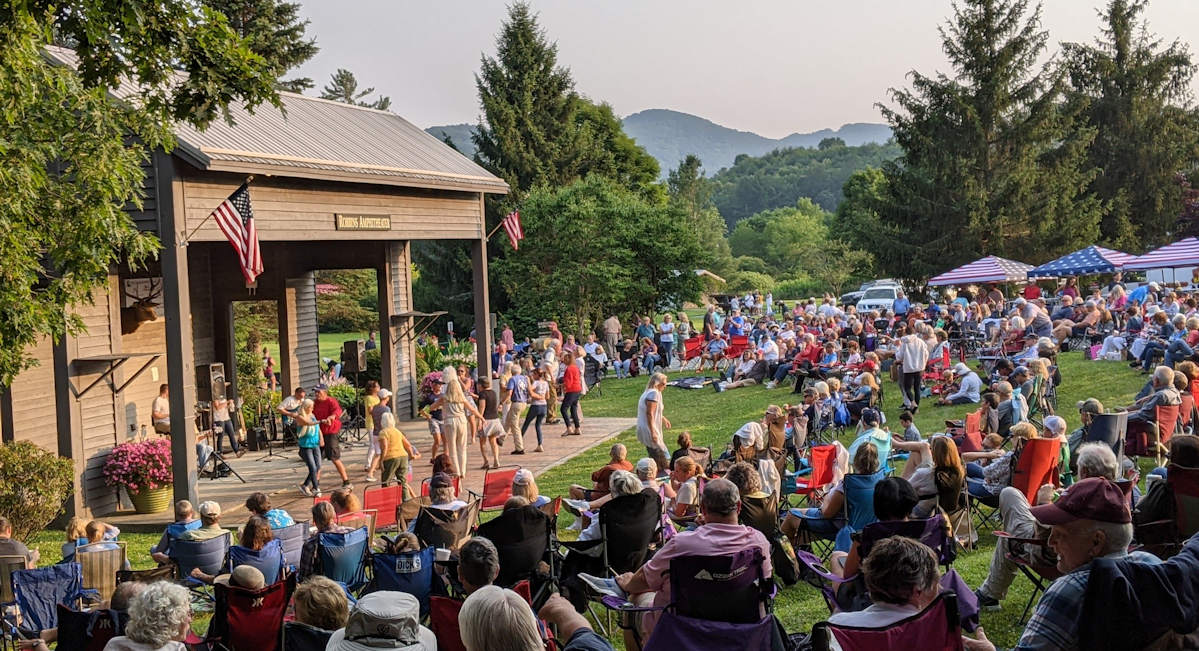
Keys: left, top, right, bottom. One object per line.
{"left": 325, "top": 590, "right": 438, "bottom": 651}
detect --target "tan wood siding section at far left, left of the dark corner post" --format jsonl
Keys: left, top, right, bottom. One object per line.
{"left": 8, "top": 337, "right": 59, "bottom": 453}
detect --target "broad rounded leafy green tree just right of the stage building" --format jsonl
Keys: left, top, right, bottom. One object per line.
{"left": 492, "top": 175, "right": 701, "bottom": 331}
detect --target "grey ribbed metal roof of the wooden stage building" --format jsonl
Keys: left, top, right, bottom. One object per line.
{"left": 46, "top": 47, "right": 508, "bottom": 194}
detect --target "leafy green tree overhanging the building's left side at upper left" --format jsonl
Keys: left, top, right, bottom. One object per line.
{"left": 0, "top": 6, "right": 278, "bottom": 385}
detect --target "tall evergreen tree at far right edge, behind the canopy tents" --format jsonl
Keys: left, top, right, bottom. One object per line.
{"left": 1062, "top": 0, "right": 1199, "bottom": 251}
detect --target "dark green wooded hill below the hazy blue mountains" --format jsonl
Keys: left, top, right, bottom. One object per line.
{"left": 712, "top": 138, "right": 900, "bottom": 229}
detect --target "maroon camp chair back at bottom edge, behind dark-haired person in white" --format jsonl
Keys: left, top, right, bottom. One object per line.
{"left": 812, "top": 592, "right": 963, "bottom": 651}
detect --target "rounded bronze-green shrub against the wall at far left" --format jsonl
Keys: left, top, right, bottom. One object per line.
{"left": 0, "top": 441, "right": 74, "bottom": 541}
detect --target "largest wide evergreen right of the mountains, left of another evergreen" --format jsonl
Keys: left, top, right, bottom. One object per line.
{"left": 875, "top": 0, "right": 1102, "bottom": 278}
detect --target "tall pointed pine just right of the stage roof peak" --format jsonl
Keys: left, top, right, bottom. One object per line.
{"left": 474, "top": 2, "right": 579, "bottom": 200}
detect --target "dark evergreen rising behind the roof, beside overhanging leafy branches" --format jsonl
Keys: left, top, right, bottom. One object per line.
{"left": 204, "top": 0, "right": 320, "bottom": 92}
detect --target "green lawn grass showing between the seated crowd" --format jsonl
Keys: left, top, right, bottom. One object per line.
{"left": 32, "top": 352, "right": 1149, "bottom": 646}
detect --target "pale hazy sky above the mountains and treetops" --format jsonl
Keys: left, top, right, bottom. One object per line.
{"left": 292, "top": 0, "right": 1199, "bottom": 138}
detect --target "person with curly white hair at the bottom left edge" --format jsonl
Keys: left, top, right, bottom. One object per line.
{"left": 104, "top": 581, "right": 192, "bottom": 651}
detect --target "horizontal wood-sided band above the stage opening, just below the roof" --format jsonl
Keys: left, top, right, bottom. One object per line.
{"left": 182, "top": 174, "right": 483, "bottom": 241}
